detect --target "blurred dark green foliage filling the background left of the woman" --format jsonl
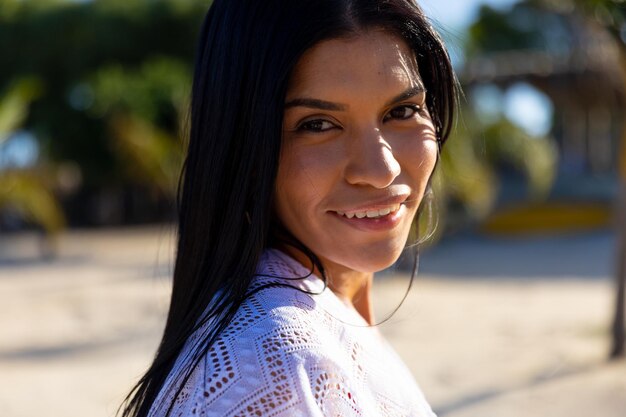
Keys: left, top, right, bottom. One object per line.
{"left": 0, "top": 0, "right": 210, "bottom": 228}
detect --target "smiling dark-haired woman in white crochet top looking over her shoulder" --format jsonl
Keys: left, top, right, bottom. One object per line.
{"left": 124, "top": 0, "right": 455, "bottom": 417}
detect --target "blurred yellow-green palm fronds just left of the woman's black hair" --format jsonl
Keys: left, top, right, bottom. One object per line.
{"left": 88, "top": 57, "right": 191, "bottom": 199}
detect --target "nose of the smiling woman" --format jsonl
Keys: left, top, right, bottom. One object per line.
{"left": 344, "top": 128, "right": 401, "bottom": 189}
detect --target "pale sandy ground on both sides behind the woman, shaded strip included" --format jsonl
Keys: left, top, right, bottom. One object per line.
{"left": 0, "top": 227, "right": 626, "bottom": 417}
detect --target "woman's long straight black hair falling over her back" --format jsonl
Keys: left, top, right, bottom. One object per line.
{"left": 122, "top": 0, "right": 456, "bottom": 417}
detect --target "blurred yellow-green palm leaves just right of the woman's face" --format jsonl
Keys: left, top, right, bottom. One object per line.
{"left": 433, "top": 109, "right": 558, "bottom": 236}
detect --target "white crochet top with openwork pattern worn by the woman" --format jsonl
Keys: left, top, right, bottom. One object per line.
{"left": 149, "top": 249, "right": 435, "bottom": 417}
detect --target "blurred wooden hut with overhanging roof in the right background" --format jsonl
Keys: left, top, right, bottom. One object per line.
{"left": 462, "top": 17, "right": 626, "bottom": 178}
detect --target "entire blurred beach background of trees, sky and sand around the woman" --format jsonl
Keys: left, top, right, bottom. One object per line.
{"left": 0, "top": 0, "right": 626, "bottom": 417}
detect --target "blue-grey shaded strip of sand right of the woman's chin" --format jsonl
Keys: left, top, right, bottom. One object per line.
{"left": 412, "top": 231, "right": 616, "bottom": 279}
